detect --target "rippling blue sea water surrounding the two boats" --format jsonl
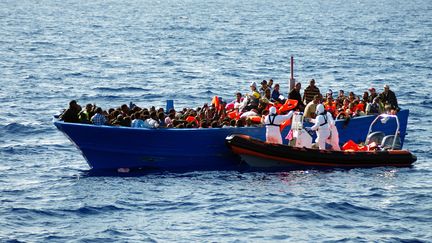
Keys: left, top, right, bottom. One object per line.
{"left": 0, "top": 0, "right": 432, "bottom": 242}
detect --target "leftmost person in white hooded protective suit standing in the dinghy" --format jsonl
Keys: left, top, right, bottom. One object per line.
{"left": 264, "top": 106, "right": 293, "bottom": 144}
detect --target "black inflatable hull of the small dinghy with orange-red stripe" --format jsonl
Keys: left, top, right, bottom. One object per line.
{"left": 226, "top": 135, "right": 417, "bottom": 170}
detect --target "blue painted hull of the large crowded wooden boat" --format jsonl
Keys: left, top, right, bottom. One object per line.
{"left": 54, "top": 110, "right": 409, "bottom": 171}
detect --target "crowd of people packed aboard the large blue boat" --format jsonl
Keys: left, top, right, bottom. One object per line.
{"left": 59, "top": 79, "right": 399, "bottom": 128}
